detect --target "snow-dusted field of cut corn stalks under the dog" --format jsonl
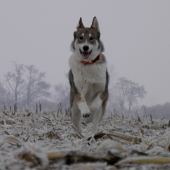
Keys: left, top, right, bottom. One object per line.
{"left": 0, "top": 105, "right": 170, "bottom": 170}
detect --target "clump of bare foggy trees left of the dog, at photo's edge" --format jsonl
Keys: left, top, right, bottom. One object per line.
{"left": 0, "top": 62, "right": 51, "bottom": 110}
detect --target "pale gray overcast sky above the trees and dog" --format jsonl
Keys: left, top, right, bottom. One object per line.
{"left": 0, "top": 0, "right": 170, "bottom": 106}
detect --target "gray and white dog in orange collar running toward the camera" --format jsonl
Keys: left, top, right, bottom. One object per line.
{"left": 69, "top": 17, "right": 109, "bottom": 134}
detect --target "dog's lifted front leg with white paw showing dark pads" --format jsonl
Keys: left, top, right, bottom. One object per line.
{"left": 74, "top": 93, "right": 91, "bottom": 118}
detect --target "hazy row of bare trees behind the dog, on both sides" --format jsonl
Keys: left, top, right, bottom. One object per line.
{"left": 0, "top": 62, "right": 147, "bottom": 113}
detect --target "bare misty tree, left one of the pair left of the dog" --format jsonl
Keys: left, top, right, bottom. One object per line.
{"left": 5, "top": 62, "right": 24, "bottom": 109}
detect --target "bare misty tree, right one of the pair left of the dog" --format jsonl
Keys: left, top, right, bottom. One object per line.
{"left": 25, "top": 65, "right": 51, "bottom": 106}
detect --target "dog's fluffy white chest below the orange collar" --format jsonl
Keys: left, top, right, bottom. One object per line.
{"left": 70, "top": 57, "right": 106, "bottom": 92}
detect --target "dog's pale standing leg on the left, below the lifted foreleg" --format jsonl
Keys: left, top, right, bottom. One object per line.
{"left": 71, "top": 102, "right": 81, "bottom": 132}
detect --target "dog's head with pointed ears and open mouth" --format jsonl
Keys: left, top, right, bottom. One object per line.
{"left": 71, "top": 17, "right": 104, "bottom": 61}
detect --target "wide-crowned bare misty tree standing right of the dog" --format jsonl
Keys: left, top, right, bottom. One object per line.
{"left": 116, "top": 77, "right": 146, "bottom": 112}
